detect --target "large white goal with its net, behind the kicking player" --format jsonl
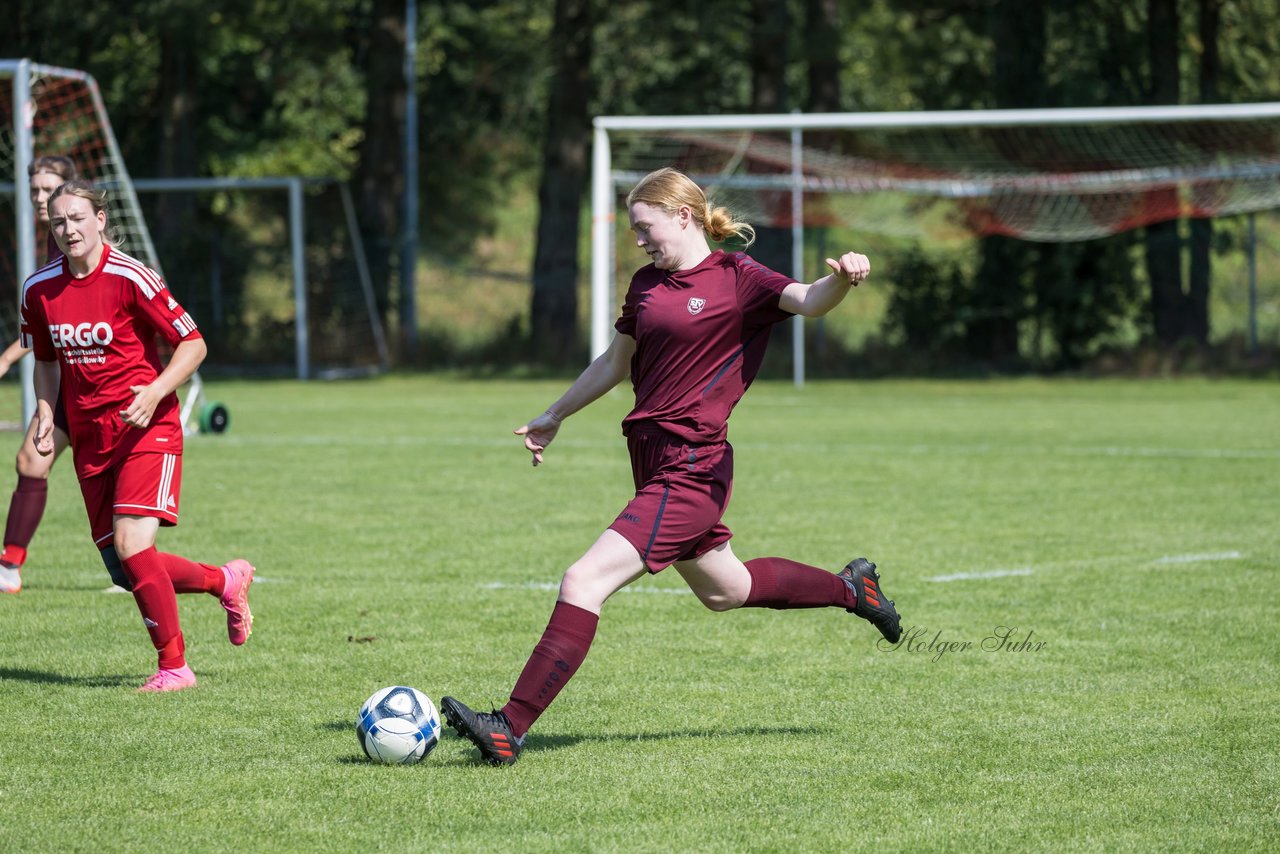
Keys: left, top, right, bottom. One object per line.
{"left": 590, "top": 102, "right": 1280, "bottom": 376}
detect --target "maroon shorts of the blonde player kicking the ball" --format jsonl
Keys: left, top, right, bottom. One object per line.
{"left": 609, "top": 428, "right": 733, "bottom": 572}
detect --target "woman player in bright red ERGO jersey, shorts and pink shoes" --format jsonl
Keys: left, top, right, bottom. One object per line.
{"left": 22, "top": 181, "right": 253, "bottom": 691}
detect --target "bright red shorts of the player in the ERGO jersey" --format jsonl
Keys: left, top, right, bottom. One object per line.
{"left": 81, "top": 453, "right": 182, "bottom": 548}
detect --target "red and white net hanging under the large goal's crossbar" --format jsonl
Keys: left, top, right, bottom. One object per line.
{"left": 609, "top": 110, "right": 1280, "bottom": 242}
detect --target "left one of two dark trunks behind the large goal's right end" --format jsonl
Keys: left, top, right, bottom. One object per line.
{"left": 1146, "top": 0, "right": 1188, "bottom": 347}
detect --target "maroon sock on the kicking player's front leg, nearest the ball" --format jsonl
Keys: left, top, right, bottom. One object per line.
{"left": 502, "top": 602, "right": 600, "bottom": 739}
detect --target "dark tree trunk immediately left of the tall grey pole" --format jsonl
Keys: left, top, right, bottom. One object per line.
{"left": 355, "top": 0, "right": 413, "bottom": 332}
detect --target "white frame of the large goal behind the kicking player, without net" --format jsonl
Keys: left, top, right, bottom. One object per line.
{"left": 590, "top": 102, "right": 1280, "bottom": 387}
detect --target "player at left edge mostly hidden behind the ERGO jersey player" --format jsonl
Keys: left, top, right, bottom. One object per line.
{"left": 0, "top": 155, "right": 79, "bottom": 593}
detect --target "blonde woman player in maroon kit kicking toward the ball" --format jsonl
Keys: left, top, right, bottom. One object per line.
{"left": 440, "top": 169, "right": 901, "bottom": 764}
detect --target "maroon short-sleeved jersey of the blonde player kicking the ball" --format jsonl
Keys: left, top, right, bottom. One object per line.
{"left": 614, "top": 250, "right": 794, "bottom": 443}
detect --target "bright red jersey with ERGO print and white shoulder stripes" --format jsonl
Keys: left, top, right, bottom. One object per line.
{"left": 22, "top": 246, "right": 200, "bottom": 478}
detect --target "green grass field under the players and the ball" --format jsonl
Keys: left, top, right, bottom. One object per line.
{"left": 0, "top": 376, "right": 1280, "bottom": 851}
